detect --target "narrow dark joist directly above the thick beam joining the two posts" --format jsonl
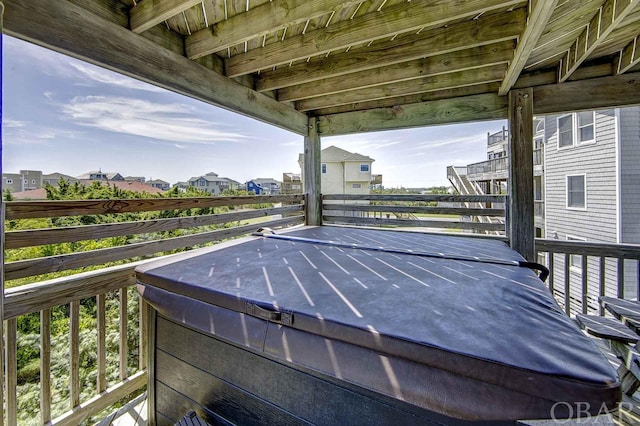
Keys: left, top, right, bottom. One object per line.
{"left": 311, "top": 82, "right": 500, "bottom": 116}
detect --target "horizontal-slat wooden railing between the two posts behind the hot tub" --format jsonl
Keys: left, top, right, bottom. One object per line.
{"left": 322, "top": 194, "right": 506, "bottom": 232}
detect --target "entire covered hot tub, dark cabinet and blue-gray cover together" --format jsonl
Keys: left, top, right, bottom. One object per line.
{"left": 137, "top": 226, "right": 620, "bottom": 425}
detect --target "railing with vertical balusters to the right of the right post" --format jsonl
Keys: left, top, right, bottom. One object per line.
{"left": 536, "top": 239, "right": 640, "bottom": 315}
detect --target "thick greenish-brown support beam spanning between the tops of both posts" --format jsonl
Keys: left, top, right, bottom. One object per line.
{"left": 318, "top": 94, "right": 507, "bottom": 136}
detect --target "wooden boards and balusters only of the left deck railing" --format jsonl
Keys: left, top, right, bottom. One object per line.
{"left": 3, "top": 195, "right": 304, "bottom": 425}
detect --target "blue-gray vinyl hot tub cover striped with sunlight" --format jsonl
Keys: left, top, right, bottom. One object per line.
{"left": 137, "top": 226, "right": 620, "bottom": 420}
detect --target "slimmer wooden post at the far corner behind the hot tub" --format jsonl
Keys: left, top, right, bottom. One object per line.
{"left": 304, "top": 117, "right": 322, "bottom": 225}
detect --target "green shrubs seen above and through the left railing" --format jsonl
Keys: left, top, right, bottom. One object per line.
{"left": 4, "top": 180, "right": 271, "bottom": 425}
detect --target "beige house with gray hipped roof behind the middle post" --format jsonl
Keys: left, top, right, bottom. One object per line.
{"left": 298, "top": 146, "right": 375, "bottom": 198}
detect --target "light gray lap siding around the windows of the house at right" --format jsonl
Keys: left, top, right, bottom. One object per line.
{"left": 545, "top": 110, "right": 635, "bottom": 308}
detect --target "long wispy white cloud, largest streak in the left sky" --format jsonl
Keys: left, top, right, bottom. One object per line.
{"left": 62, "top": 96, "right": 250, "bottom": 143}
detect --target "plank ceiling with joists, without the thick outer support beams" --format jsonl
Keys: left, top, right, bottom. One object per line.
{"left": 5, "top": 0, "right": 640, "bottom": 134}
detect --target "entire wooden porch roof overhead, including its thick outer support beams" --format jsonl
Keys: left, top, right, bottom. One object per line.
{"left": 3, "top": 0, "right": 640, "bottom": 135}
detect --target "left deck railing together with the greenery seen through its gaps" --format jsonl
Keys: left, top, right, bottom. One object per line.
{"left": 0, "top": 195, "right": 304, "bottom": 425}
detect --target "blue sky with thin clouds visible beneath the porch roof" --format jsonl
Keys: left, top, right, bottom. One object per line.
{"left": 2, "top": 36, "right": 506, "bottom": 188}
